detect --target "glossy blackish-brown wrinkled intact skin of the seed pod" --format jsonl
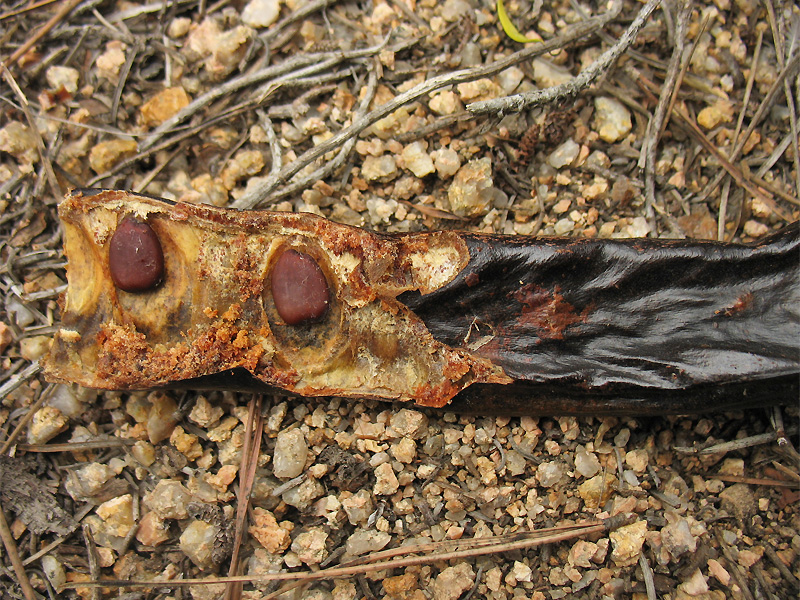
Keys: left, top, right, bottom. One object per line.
{"left": 400, "top": 223, "right": 800, "bottom": 414}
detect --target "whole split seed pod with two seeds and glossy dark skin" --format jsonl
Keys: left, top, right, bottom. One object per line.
{"left": 44, "top": 190, "right": 800, "bottom": 415}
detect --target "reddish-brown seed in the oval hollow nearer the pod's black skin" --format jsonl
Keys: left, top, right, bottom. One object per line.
{"left": 272, "top": 250, "right": 331, "bottom": 325}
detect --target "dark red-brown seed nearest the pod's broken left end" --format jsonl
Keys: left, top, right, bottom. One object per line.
{"left": 108, "top": 217, "right": 164, "bottom": 292}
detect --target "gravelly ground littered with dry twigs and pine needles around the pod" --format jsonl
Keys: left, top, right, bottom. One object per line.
{"left": 0, "top": 0, "right": 800, "bottom": 600}
